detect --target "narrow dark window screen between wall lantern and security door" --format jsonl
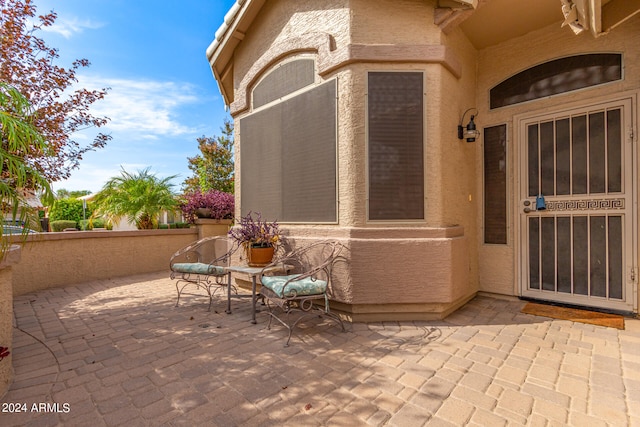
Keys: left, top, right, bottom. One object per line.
{"left": 483, "top": 125, "right": 507, "bottom": 244}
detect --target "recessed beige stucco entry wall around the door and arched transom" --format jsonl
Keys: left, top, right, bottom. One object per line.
{"left": 476, "top": 16, "right": 640, "bottom": 308}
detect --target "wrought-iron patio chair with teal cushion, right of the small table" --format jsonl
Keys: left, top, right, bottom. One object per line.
{"left": 260, "top": 240, "right": 346, "bottom": 347}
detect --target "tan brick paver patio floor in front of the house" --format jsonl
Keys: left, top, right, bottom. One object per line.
{"left": 0, "top": 273, "right": 640, "bottom": 427}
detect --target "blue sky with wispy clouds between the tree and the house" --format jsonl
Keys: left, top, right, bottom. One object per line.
{"left": 35, "top": 0, "right": 235, "bottom": 192}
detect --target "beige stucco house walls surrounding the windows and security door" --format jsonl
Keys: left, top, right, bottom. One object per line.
{"left": 207, "top": 0, "right": 640, "bottom": 320}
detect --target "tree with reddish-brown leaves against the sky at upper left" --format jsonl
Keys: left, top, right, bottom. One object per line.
{"left": 0, "top": 0, "right": 111, "bottom": 182}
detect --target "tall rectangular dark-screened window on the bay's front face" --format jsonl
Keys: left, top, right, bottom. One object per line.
{"left": 367, "top": 72, "right": 424, "bottom": 220}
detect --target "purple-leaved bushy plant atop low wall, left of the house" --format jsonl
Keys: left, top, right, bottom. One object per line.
{"left": 180, "top": 190, "right": 235, "bottom": 223}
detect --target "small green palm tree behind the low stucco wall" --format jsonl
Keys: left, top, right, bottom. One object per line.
{"left": 94, "top": 168, "right": 176, "bottom": 230}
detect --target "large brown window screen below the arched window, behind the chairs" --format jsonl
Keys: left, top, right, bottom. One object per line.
{"left": 240, "top": 80, "right": 337, "bottom": 222}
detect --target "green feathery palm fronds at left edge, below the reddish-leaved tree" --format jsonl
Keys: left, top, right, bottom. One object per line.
{"left": 0, "top": 82, "right": 53, "bottom": 259}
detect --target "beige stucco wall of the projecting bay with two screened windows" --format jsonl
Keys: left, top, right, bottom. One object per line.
{"left": 225, "top": 0, "right": 478, "bottom": 318}
